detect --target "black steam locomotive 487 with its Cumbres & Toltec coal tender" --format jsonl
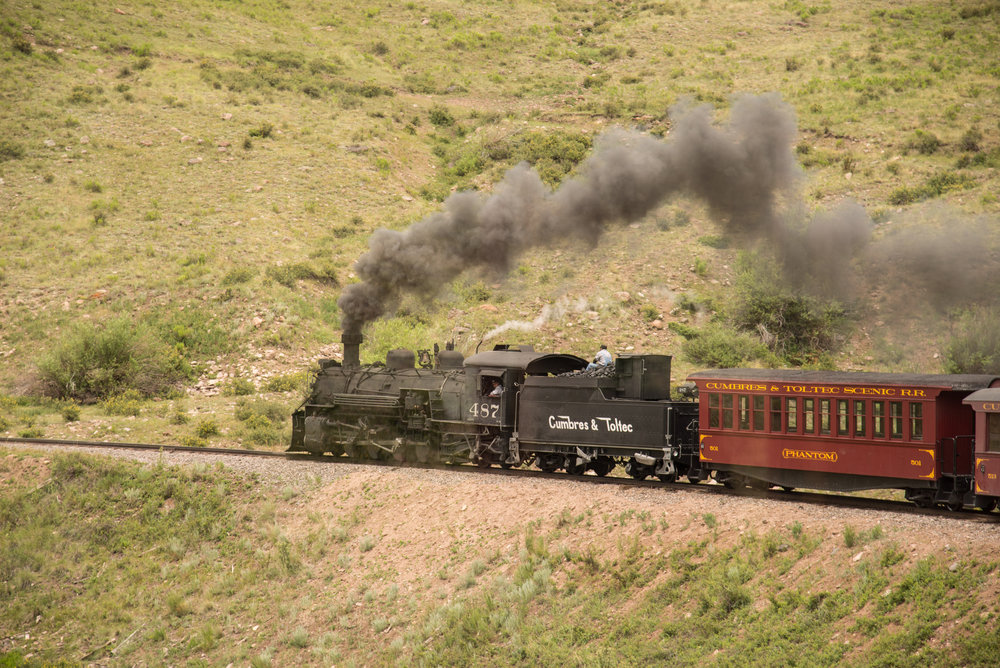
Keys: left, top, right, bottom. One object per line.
{"left": 289, "top": 334, "right": 708, "bottom": 482}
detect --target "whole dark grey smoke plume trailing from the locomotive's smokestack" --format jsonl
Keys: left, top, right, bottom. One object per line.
{"left": 338, "top": 93, "right": 1000, "bottom": 333}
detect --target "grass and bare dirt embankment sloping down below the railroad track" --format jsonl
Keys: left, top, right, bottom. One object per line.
{"left": 0, "top": 451, "right": 1000, "bottom": 668}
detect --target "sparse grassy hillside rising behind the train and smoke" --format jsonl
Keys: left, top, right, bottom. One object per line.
{"left": 0, "top": 0, "right": 1000, "bottom": 408}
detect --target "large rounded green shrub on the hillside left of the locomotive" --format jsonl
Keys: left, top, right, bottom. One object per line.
{"left": 37, "top": 318, "right": 188, "bottom": 401}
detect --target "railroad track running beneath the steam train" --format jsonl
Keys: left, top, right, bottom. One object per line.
{"left": 0, "top": 437, "right": 1000, "bottom": 524}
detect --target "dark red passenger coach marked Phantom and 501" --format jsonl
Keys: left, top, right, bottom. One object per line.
{"left": 689, "top": 369, "right": 1000, "bottom": 507}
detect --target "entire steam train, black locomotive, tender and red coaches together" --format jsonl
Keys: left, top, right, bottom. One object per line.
{"left": 289, "top": 334, "right": 1000, "bottom": 511}
